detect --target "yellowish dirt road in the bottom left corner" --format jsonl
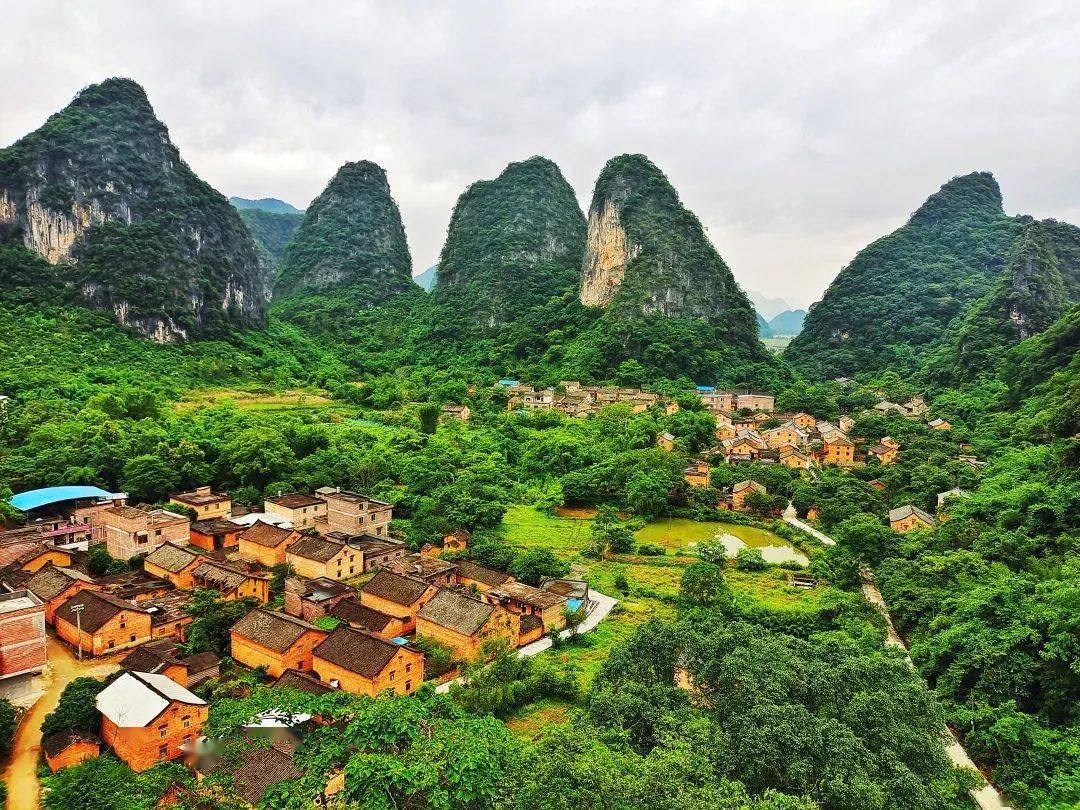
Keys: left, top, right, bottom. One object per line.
{"left": 4, "top": 636, "right": 120, "bottom": 810}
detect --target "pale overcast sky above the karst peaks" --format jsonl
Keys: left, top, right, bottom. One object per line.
{"left": 0, "top": 0, "right": 1080, "bottom": 306}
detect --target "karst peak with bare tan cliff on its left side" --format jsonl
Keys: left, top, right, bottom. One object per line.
{"left": 580, "top": 154, "right": 757, "bottom": 342}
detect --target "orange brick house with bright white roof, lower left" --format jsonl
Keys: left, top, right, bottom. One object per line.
{"left": 97, "top": 672, "right": 206, "bottom": 772}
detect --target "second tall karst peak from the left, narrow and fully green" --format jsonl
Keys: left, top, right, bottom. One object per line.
{"left": 274, "top": 161, "right": 416, "bottom": 328}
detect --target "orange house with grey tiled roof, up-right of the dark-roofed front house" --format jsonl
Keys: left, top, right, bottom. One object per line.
{"left": 416, "top": 588, "right": 518, "bottom": 661}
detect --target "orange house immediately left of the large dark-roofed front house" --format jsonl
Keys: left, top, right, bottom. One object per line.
{"left": 230, "top": 608, "right": 328, "bottom": 677}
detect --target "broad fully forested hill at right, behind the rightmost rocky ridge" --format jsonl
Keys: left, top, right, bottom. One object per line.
{"left": 784, "top": 172, "right": 1023, "bottom": 377}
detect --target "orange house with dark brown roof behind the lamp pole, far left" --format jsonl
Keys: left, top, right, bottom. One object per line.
{"left": 55, "top": 591, "right": 153, "bottom": 656}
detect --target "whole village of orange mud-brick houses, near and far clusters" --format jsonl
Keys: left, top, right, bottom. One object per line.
{"left": 0, "top": 380, "right": 980, "bottom": 807}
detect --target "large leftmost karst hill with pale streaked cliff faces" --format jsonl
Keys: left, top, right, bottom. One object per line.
{"left": 0, "top": 79, "right": 266, "bottom": 341}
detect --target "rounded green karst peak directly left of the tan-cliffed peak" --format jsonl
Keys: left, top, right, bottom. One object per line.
{"left": 433, "top": 157, "right": 585, "bottom": 338}
